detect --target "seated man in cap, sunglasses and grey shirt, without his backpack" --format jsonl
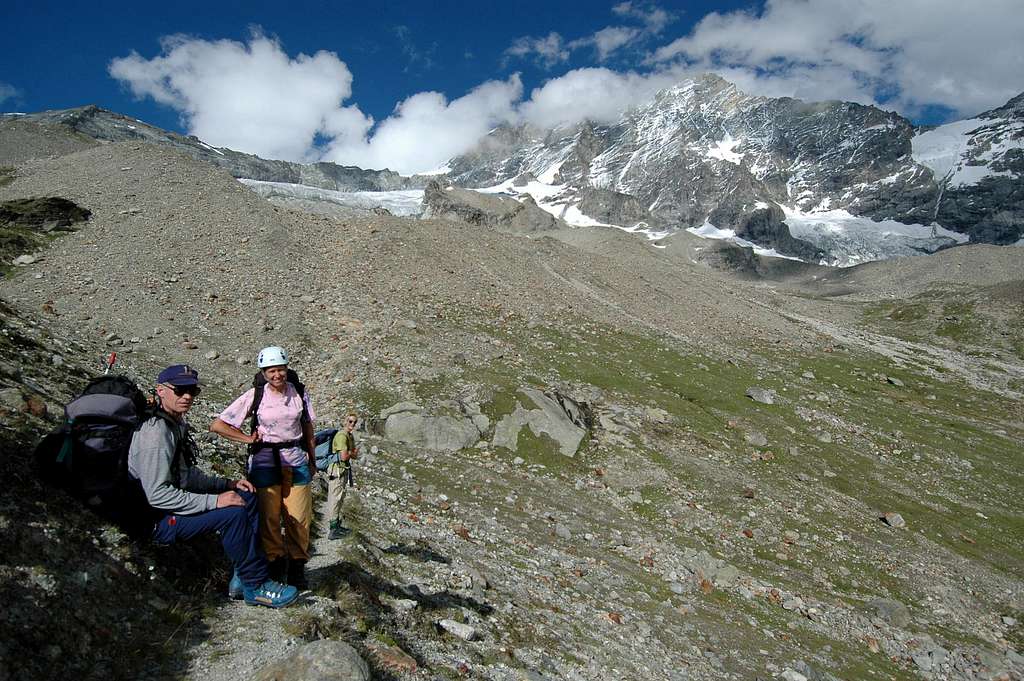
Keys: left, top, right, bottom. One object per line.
{"left": 128, "top": 365, "right": 298, "bottom": 607}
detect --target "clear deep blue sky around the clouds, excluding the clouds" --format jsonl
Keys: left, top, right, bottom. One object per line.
{"left": 0, "top": 0, "right": 750, "bottom": 129}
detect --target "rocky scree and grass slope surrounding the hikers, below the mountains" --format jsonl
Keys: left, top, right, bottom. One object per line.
{"left": 0, "top": 122, "right": 1024, "bottom": 681}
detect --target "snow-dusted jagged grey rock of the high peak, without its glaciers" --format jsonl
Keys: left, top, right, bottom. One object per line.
{"left": 450, "top": 75, "right": 1024, "bottom": 251}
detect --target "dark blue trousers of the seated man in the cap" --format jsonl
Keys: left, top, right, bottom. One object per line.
{"left": 153, "top": 491, "right": 267, "bottom": 587}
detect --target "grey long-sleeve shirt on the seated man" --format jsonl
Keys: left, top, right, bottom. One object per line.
{"left": 128, "top": 417, "right": 228, "bottom": 515}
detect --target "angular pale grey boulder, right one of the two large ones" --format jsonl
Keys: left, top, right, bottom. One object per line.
{"left": 492, "top": 388, "right": 591, "bottom": 457}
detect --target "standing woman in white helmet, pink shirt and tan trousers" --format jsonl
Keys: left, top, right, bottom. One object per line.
{"left": 210, "top": 345, "right": 316, "bottom": 589}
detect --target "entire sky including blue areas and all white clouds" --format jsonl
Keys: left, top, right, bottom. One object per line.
{"left": 0, "top": 0, "right": 1024, "bottom": 172}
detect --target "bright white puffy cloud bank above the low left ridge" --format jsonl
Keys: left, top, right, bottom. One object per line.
{"left": 110, "top": 34, "right": 522, "bottom": 173}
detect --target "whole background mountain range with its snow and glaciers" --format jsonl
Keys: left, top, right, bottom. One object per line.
{"left": 8, "top": 74, "right": 1024, "bottom": 265}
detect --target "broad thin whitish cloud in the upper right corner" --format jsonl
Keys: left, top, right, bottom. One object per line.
{"left": 652, "top": 0, "right": 1024, "bottom": 116}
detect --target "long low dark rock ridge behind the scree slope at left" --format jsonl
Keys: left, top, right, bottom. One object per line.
{"left": 4, "top": 107, "right": 429, "bottom": 191}
